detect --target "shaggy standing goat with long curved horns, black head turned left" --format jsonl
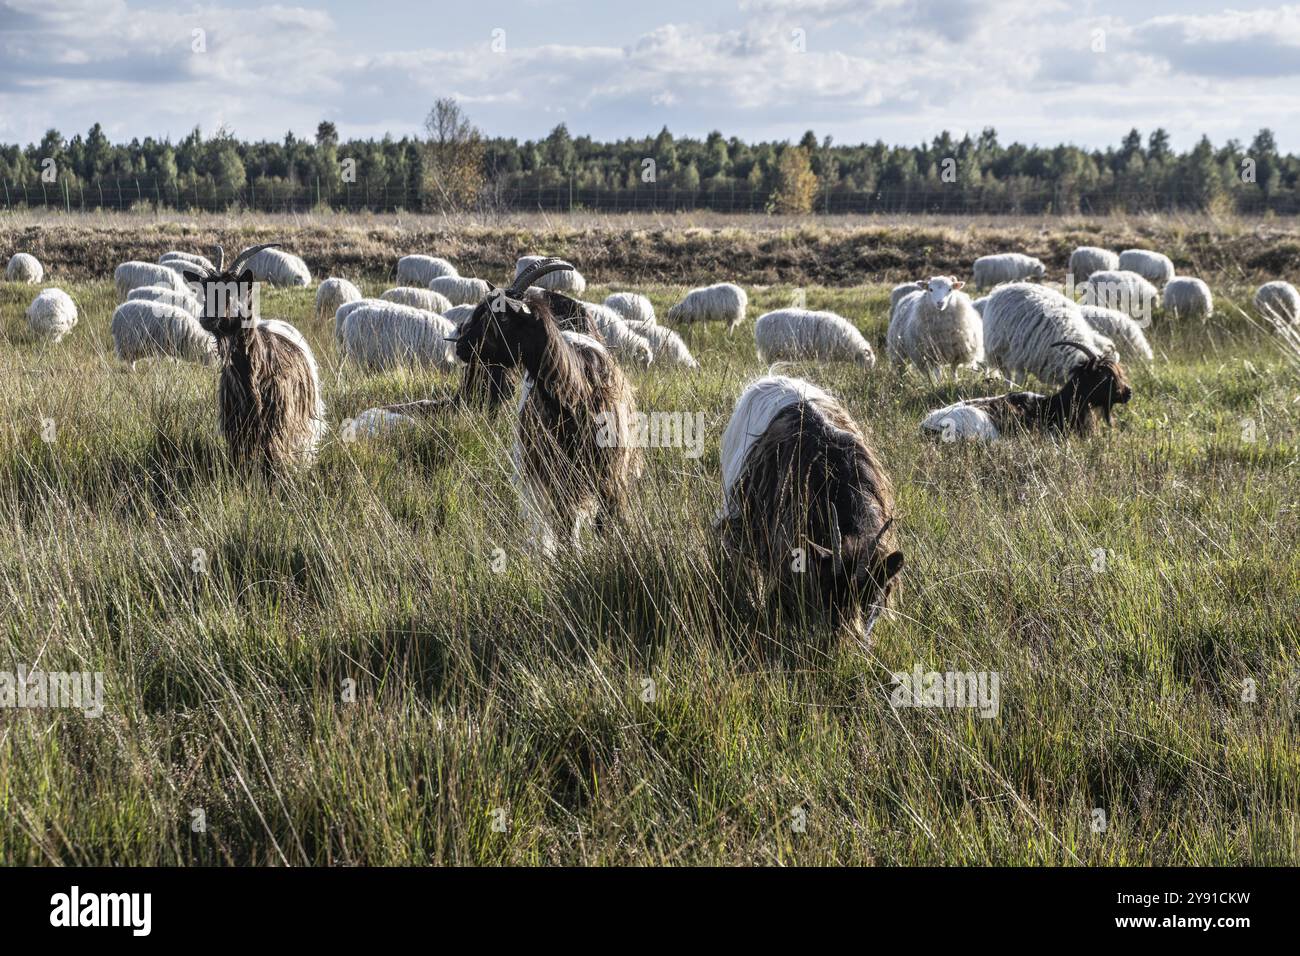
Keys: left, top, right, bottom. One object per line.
{"left": 456, "top": 259, "right": 641, "bottom": 554}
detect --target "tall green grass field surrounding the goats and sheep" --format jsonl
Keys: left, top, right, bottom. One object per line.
{"left": 0, "top": 270, "right": 1300, "bottom": 865}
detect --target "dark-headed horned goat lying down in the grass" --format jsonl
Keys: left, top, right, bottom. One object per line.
{"left": 920, "top": 342, "right": 1132, "bottom": 441}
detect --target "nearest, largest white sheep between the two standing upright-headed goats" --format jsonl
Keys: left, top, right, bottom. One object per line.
{"left": 343, "top": 302, "right": 456, "bottom": 372}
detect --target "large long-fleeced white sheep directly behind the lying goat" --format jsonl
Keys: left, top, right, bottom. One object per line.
{"left": 984, "top": 282, "right": 1117, "bottom": 385}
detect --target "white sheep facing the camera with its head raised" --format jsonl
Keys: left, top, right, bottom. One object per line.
{"left": 885, "top": 276, "right": 984, "bottom": 380}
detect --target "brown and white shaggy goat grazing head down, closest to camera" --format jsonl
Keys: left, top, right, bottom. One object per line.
{"left": 718, "top": 376, "right": 904, "bottom": 640}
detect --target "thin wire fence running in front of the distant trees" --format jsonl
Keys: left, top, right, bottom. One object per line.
{"left": 0, "top": 177, "right": 1300, "bottom": 216}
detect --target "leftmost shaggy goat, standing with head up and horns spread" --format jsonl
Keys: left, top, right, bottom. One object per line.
{"left": 186, "top": 245, "right": 328, "bottom": 477}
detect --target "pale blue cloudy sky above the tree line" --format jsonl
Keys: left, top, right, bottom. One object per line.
{"left": 0, "top": 0, "right": 1300, "bottom": 152}
